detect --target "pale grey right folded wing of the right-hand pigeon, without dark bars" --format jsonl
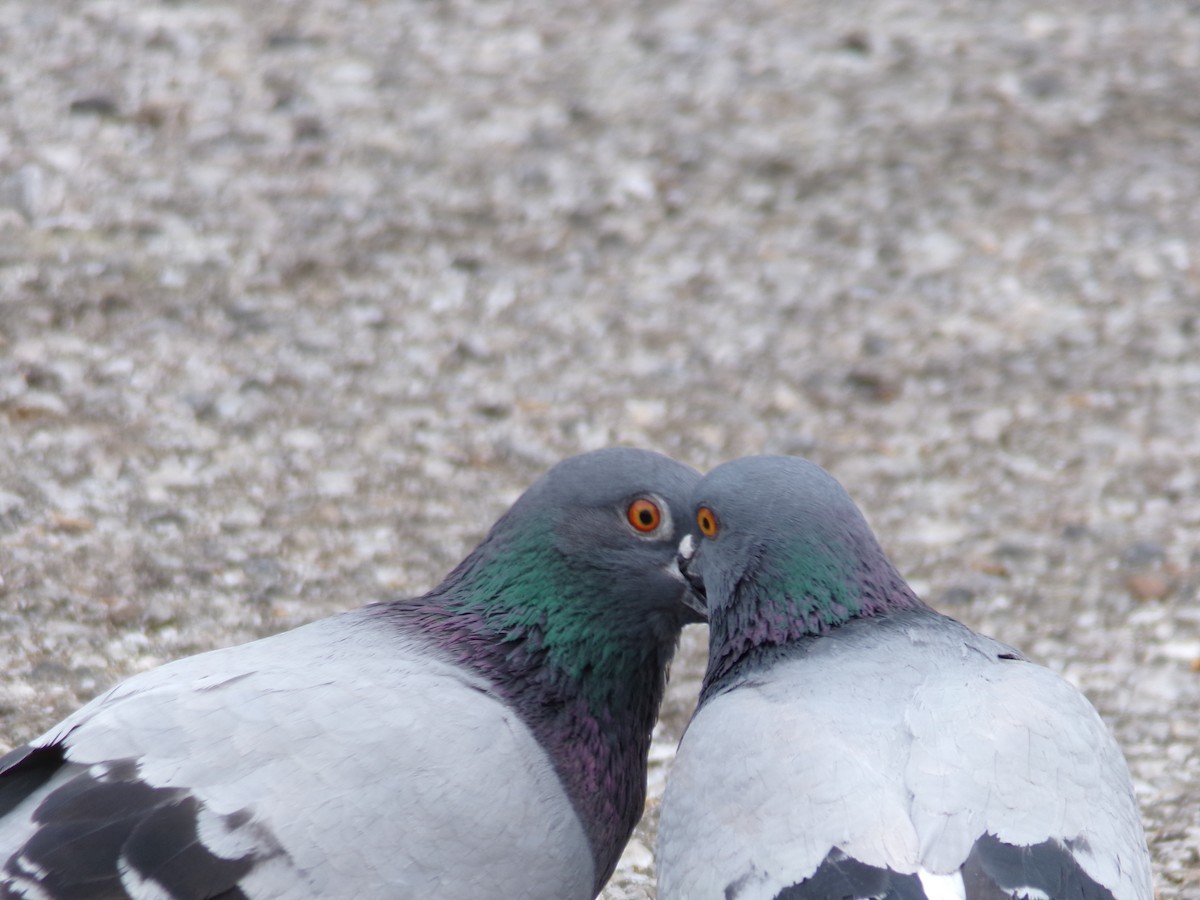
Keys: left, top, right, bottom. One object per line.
{"left": 906, "top": 661, "right": 1150, "bottom": 898}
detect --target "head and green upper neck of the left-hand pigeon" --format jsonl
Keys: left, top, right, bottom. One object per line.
{"left": 463, "top": 448, "right": 703, "bottom": 648}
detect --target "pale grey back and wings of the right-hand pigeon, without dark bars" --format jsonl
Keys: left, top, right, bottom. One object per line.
{"left": 660, "top": 614, "right": 1151, "bottom": 900}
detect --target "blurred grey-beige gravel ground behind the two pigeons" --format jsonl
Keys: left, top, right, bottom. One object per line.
{"left": 0, "top": 0, "right": 1200, "bottom": 900}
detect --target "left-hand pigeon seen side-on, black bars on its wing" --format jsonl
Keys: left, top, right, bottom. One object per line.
{"left": 0, "top": 449, "right": 702, "bottom": 900}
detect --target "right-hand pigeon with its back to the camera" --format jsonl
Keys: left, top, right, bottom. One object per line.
{"left": 658, "top": 456, "right": 1153, "bottom": 900}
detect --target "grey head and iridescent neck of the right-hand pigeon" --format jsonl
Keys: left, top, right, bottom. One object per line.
{"left": 680, "top": 456, "right": 920, "bottom": 681}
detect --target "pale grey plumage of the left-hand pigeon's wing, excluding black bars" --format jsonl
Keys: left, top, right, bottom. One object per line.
{"left": 0, "top": 613, "right": 593, "bottom": 900}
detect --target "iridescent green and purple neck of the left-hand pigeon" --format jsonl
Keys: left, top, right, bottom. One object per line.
{"left": 391, "top": 511, "right": 684, "bottom": 892}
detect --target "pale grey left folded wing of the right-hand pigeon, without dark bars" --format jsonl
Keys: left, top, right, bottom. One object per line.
{"left": 659, "top": 682, "right": 918, "bottom": 900}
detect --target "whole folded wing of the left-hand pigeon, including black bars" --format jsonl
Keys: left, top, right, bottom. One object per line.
{"left": 0, "top": 613, "right": 593, "bottom": 900}
